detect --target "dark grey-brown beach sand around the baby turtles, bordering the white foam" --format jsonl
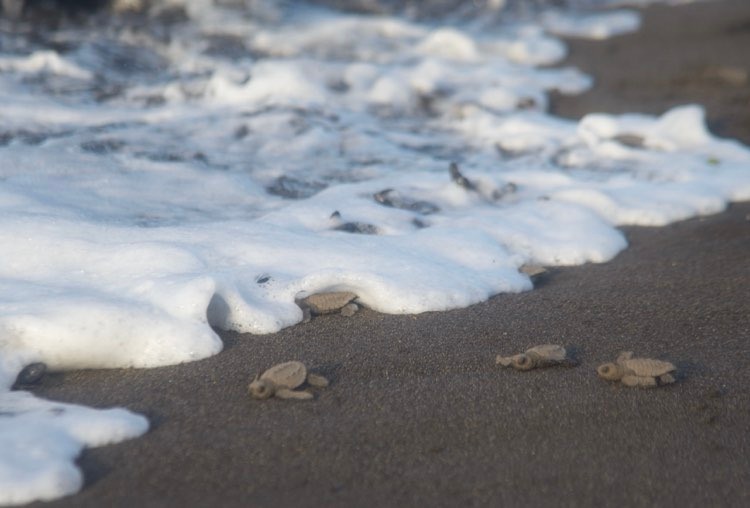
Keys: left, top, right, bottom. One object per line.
{"left": 30, "top": 0, "right": 750, "bottom": 507}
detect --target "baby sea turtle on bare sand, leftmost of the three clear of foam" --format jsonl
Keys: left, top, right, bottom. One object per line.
{"left": 247, "top": 361, "right": 328, "bottom": 400}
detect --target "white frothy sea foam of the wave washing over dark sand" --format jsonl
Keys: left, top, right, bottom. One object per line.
{"left": 0, "top": 0, "right": 750, "bottom": 505}
